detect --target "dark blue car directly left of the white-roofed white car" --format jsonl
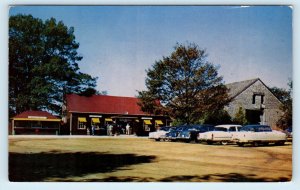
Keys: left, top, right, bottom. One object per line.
{"left": 177, "top": 124, "right": 214, "bottom": 142}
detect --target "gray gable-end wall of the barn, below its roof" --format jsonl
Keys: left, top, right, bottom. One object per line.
{"left": 225, "top": 80, "right": 283, "bottom": 127}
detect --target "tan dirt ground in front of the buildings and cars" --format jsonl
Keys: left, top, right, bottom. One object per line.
{"left": 9, "top": 137, "right": 292, "bottom": 182}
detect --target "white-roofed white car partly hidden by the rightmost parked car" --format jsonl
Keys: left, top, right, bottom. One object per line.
{"left": 198, "top": 124, "right": 242, "bottom": 145}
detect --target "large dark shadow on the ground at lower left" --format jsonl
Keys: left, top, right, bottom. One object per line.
{"left": 9, "top": 152, "right": 155, "bottom": 181}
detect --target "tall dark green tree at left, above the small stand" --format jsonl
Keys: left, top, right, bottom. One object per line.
{"left": 9, "top": 15, "right": 97, "bottom": 115}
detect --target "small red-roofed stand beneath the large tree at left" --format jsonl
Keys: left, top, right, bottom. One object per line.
{"left": 11, "top": 111, "right": 61, "bottom": 135}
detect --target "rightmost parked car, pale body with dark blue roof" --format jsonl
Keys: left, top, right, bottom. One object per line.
{"left": 233, "top": 125, "right": 287, "bottom": 146}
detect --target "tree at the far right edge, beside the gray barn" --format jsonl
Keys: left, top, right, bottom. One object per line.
{"left": 270, "top": 80, "right": 293, "bottom": 129}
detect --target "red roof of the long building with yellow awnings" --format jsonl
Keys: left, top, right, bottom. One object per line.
{"left": 66, "top": 94, "right": 149, "bottom": 115}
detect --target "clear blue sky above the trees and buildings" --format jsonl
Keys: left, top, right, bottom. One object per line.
{"left": 9, "top": 6, "right": 293, "bottom": 96}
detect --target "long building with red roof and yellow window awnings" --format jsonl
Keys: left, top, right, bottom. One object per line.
{"left": 62, "top": 94, "right": 171, "bottom": 135}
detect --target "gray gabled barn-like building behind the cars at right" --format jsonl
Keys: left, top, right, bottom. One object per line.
{"left": 225, "top": 78, "right": 283, "bottom": 128}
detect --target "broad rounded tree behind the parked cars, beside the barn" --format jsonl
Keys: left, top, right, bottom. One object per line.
{"left": 138, "top": 43, "right": 228, "bottom": 124}
